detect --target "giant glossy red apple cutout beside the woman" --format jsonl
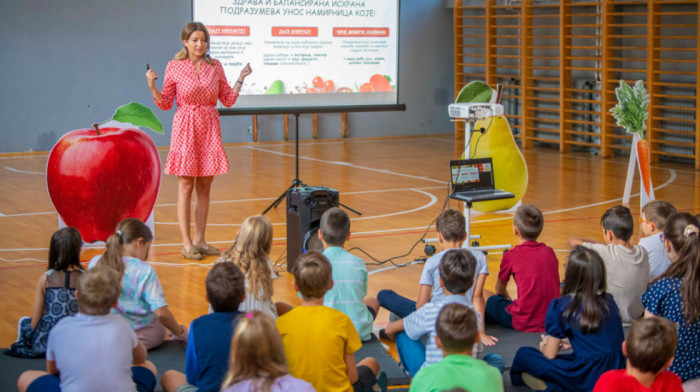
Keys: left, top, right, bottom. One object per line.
{"left": 46, "top": 103, "right": 162, "bottom": 243}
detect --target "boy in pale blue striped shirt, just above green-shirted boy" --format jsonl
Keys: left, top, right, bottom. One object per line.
{"left": 385, "top": 249, "right": 503, "bottom": 376}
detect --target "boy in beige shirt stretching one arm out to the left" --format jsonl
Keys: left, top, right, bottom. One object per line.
{"left": 568, "top": 206, "right": 649, "bottom": 324}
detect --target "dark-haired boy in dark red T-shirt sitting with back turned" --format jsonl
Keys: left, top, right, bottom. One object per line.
{"left": 485, "top": 204, "right": 560, "bottom": 332}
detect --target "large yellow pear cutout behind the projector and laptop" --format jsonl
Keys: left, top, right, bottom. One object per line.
{"left": 456, "top": 81, "right": 528, "bottom": 212}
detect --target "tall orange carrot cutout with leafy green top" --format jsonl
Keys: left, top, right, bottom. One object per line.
{"left": 610, "top": 80, "right": 651, "bottom": 198}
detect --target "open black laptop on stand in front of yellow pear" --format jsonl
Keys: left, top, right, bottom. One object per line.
{"left": 450, "top": 158, "right": 515, "bottom": 203}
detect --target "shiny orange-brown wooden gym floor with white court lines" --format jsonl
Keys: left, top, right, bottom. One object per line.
{"left": 0, "top": 135, "right": 700, "bottom": 347}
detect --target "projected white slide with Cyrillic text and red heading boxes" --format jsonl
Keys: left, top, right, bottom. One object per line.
{"left": 193, "top": 0, "right": 398, "bottom": 108}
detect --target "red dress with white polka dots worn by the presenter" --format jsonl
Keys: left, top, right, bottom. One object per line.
{"left": 154, "top": 59, "right": 238, "bottom": 177}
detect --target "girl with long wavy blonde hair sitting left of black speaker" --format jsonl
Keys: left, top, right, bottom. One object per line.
{"left": 217, "top": 215, "right": 288, "bottom": 319}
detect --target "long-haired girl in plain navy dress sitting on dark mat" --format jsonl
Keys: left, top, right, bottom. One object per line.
{"left": 510, "top": 246, "right": 625, "bottom": 392}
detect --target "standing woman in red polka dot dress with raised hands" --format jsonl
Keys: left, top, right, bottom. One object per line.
{"left": 146, "top": 22, "right": 253, "bottom": 260}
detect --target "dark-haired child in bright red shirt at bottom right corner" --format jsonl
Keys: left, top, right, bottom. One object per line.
{"left": 593, "top": 317, "right": 683, "bottom": 392}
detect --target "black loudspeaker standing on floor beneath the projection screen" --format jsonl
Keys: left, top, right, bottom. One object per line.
{"left": 287, "top": 186, "right": 339, "bottom": 272}
